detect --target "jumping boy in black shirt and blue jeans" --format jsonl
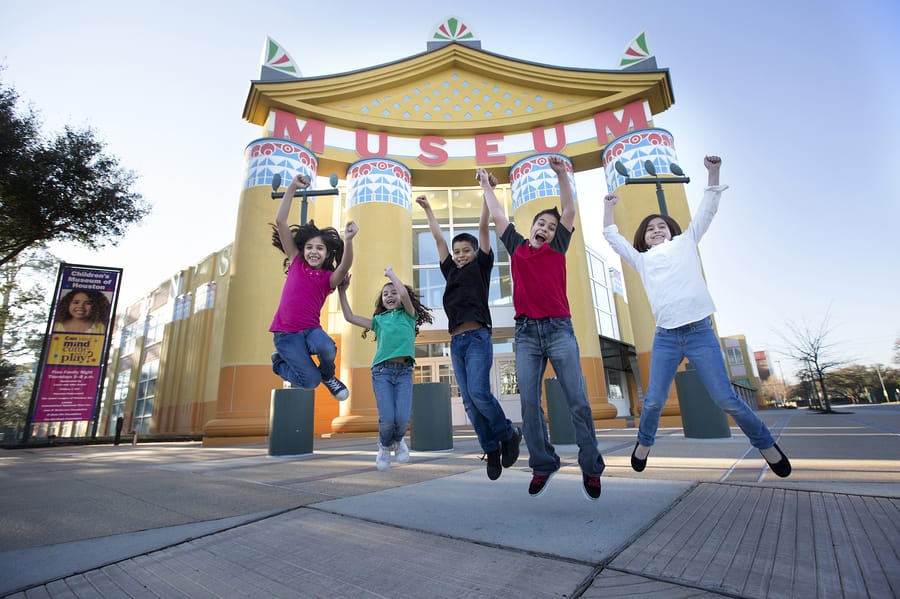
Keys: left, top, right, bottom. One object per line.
{"left": 416, "top": 188, "right": 522, "bottom": 480}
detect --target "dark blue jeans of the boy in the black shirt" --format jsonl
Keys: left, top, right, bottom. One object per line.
{"left": 450, "top": 327, "right": 515, "bottom": 453}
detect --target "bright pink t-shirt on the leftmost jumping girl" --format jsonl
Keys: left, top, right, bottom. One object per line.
{"left": 269, "top": 254, "right": 334, "bottom": 333}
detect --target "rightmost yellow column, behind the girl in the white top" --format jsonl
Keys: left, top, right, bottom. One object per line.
{"left": 603, "top": 129, "right": 691, "bottom": 426}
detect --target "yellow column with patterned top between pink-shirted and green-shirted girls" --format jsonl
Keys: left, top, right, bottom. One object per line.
{"left": 332, "top": 158, "right": 413, "bottom": 432}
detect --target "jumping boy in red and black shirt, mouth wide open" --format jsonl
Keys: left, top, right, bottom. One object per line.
{"left": 476, "top": 156, "right": 605, "bottom": 501}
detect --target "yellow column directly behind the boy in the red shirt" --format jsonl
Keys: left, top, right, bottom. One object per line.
{"left": 509, "top": 154, "right": 616, "bottom": 420}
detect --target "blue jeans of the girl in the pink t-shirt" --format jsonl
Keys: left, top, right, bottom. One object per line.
{"left": 272, "top": 328, "right": 337, "bottom": 389}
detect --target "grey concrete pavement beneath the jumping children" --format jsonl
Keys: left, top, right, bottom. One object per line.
{"left": 0, "top": 404, "right": 900, "bottom": 598}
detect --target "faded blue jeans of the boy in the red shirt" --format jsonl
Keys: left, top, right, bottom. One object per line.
{"left": 516, "top": 318, "right": 605, "bottom": 476}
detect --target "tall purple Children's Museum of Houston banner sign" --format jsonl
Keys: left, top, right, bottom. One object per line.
{"left": 31, "top": 264, "right": 122, "bottom": 422}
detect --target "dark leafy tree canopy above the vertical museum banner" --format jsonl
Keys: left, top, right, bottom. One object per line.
{"left": 0, "top": 71, "right": 150, "bottom": 266}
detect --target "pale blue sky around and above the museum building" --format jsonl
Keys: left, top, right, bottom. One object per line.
{"left": 0, "top": 0, "right": 900, "bottom": 380}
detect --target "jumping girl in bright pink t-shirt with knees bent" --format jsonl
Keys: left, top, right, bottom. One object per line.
{"left": 269, "top": 175, "right": 359, "bottom": 401}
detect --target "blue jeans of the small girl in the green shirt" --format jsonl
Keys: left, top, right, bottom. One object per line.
{"left": 372, "top": 362, "right": 413, "bottom": 447}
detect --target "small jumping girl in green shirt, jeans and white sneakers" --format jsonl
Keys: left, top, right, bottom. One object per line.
{"left": 338, "top": 266, "right": 433, "bottom": 470}
